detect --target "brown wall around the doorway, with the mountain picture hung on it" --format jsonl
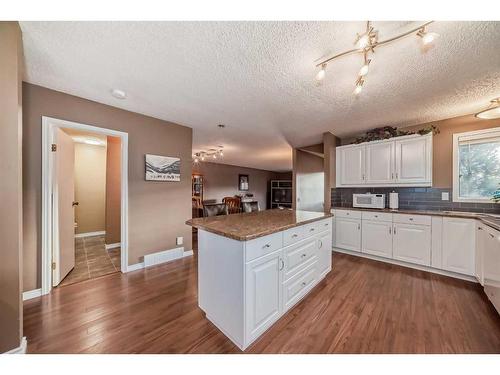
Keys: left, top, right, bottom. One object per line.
{"left": 23, "top": 83, "right": 192, "bottom": 290}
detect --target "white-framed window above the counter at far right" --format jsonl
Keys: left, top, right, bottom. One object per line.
{"left": 453, "top": 128, "right": 500, "bottom": 203}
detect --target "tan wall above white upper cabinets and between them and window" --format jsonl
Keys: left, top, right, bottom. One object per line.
{"left": 342, "top": 115, "right": 500, "bottom": 188}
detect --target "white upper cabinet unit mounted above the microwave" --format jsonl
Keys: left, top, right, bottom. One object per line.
{"left": 336, "top": 133, "right": 432, "bottom": 187}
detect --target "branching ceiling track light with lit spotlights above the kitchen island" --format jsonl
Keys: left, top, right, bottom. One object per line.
{"left": 316, "top": 21, "right": 439, "bottom": 95}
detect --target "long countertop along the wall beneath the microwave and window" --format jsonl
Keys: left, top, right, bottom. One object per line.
{"left": 332, "top": 207, "right": 500, "bottom": 230}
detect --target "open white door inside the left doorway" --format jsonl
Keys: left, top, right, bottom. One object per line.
{"left": 52, "top": 128, "right": 75, "bottom": 286}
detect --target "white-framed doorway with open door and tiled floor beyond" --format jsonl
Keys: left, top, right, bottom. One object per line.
{"left": 42, "top": 117, "right": 128, "bottom": 294}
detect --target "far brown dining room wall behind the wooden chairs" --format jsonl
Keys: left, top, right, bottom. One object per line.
{"left": 193, "top": 162, "right": 289, "bottom": 209}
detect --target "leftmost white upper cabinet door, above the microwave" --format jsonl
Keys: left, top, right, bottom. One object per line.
{"left": 337, "top": 146, "right": 365, "bottom": 186}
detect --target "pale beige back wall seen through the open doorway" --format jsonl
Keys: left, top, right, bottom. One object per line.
{"left": 75, "top": 143, "right": 106, "bottom": 233}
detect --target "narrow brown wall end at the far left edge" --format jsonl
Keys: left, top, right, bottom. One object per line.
{"left": 0, "top": 22, "right": 23, "bottom": 353}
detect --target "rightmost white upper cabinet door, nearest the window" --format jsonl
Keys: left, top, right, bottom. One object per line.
{"left": 394, "top": 136, "right": 432, "bottom": 184}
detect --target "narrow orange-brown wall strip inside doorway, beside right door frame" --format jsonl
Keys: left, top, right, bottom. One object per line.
{"left": 106, "top": 137, "right": 121, "bottom": 245}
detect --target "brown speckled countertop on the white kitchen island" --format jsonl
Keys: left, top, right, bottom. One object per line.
{"left": 186, "top": 209, "right": 332, "bottom": 241}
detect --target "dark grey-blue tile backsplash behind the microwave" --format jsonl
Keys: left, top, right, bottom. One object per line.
{"left": 331, "top": 187, "right": 500, "bottom": 214}
